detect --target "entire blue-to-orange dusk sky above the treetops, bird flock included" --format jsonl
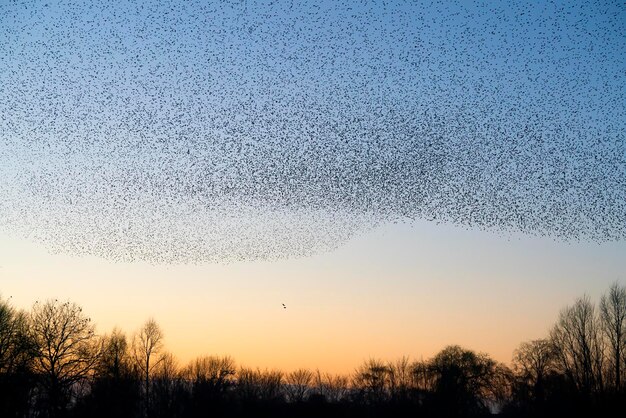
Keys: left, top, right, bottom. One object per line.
{"left": 0, "top": 0, "right": 626, "bottom": 373}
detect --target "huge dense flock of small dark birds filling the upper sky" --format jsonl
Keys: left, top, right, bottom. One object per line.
{"left": 0, "top": 0, "right": 626, "bottom": 263}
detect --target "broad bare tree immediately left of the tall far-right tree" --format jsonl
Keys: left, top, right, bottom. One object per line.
{"left": 550, "top": 296, "right": 604, "bottom": 396}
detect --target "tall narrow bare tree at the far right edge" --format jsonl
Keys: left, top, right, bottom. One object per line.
{"left": 600, "top": 283, "right": 626, "bottom": 392}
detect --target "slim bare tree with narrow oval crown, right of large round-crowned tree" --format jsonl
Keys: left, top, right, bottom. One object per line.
{"left": 132, "top": 318, "right": 163, "bottom": 416}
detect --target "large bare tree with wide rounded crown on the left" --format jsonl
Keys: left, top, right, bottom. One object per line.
{"left": 30, "top": 300, "right": 100, "bottom": 416}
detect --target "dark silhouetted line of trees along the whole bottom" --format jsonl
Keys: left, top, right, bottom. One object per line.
{"left": 0, "top": 283, "right": 626, "bottom": 418}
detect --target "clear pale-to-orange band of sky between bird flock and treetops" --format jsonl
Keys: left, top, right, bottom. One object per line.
{"left": 0, "top": 222, "right": 626, "bottom": 373}
